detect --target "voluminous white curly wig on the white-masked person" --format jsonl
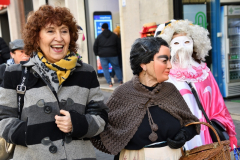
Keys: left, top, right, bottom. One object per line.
{"left": 155, "top": 20, "right": 212, "bottom": 61}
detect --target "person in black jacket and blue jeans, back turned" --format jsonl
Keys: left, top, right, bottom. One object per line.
{"left": 93, "top": 23, "right": 122, "bottom": 87}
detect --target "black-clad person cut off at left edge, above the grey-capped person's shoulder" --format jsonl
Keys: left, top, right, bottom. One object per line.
{"left": 0, "top": 37, "right": 10, "bottom": 64}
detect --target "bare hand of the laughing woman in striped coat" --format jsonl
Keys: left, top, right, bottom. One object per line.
{"left": 55, "top": 110, "right": 72, "bottom": 133}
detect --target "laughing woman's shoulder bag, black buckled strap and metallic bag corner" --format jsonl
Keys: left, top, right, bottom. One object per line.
{"left": 0, "top": 67, "right": 29, "bottom": 160}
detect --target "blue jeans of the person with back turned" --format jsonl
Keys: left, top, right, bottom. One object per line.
{"left": 100, "top": 56, "right": 122, "bottom": 84}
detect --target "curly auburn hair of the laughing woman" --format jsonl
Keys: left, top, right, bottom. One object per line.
{"left": 22, "top": 5, "right": 78, "bottom": 56}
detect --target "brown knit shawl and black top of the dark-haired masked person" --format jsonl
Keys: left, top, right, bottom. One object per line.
{"left": 92, "top": 75, "right": 200, "bottom": 156}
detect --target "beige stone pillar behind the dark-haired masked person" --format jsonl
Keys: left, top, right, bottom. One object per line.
{"left": 119, "top": 0, "right": 173, "bottom": 82}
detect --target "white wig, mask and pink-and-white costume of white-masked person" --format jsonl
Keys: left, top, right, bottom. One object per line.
{"left": 155, "top": 20, "right": 237, "bottom": 150}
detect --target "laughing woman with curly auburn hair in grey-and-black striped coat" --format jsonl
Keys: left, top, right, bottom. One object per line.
{"left": 0, "top": 5, "right": 108, "bottom": 160}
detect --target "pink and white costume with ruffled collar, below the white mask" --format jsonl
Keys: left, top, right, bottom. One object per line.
{"left": 168, "top": 63, "right": 236, "bottom": 150}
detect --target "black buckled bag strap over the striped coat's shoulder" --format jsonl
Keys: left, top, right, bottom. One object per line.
{"left": 16, "top": 67, "right": 30, "bottom": 119}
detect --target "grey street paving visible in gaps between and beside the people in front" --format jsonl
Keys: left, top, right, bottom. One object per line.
{"left": 96, "top": 90, "right": 240, "bottom": 160}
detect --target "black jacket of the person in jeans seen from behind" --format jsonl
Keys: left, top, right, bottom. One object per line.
{"left": 93, "top": 29, "right": 121, "bottom": 57}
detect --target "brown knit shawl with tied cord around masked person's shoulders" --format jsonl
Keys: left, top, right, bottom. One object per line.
{"left": 91, "top": 76, "right": 200, "bottom": 155}
